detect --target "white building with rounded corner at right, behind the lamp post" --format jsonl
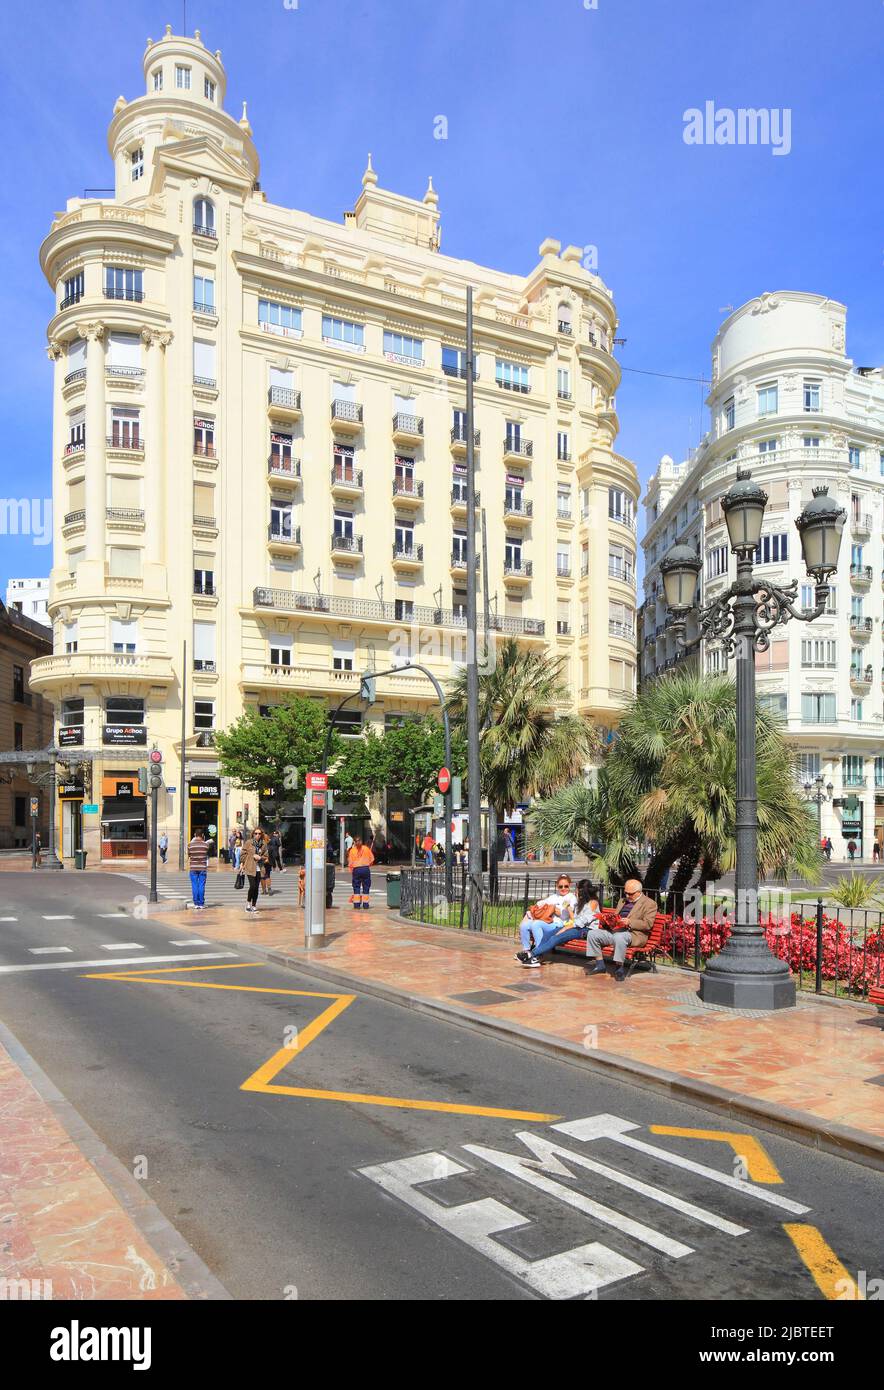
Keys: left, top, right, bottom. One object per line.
{"left": 642, "top": 292, "right": 884, "bottom": 859}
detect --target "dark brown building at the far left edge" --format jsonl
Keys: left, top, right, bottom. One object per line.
{"left": 0, "top": 603, "right": 53, "bottom": 849}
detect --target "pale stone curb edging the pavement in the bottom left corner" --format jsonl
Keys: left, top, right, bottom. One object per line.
{"left": 0, "top": 1023, "right": 234, "bottom": 1302}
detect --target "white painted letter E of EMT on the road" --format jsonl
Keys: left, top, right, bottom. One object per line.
{"left": 360, "top": 1154, "right": 642, "bottom": 1298}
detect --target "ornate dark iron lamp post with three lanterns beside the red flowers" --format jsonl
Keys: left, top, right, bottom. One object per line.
{"left": 660, "top": 468, "right": 846, "bottom": 1009}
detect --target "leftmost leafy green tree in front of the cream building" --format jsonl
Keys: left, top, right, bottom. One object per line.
{"left": 215, "top": 695, "right": 343, "bottom": 805}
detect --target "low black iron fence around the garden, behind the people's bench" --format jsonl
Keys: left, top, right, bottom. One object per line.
{"left": 400, "top": 865, "right": 884, "bottom": 999}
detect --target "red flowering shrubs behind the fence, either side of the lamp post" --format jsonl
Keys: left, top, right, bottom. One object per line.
{"left": 663, "top": 912, "right": 884, "bottom": 994}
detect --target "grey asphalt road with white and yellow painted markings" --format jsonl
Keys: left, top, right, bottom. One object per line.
{"left": 0, "top": 872, "right": 883, "bottom": 1300}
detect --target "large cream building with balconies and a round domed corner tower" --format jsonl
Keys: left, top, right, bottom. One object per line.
{"left": 32, "top": 31, "right": 638, "bottom": 855}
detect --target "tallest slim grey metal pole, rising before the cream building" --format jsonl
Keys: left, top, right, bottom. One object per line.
{"left": 467, "top": 285, "right": 482, "bottom": 931}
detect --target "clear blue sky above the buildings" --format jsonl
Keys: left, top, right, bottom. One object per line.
{"left": 0, "top": 0, "right": 884, "bottom": 595}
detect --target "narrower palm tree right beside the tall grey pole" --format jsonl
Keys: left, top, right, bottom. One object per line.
{"left": 448, "top": 638, "right": 600, "bottom": 863}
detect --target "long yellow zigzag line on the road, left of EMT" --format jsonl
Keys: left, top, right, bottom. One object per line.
{"left": 83, "top": 962, "right": 562, "bottom": 1123}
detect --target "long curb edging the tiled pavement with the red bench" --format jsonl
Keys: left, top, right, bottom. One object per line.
{"left": 231, "top": 941, "right": 884, "bottom": 1170}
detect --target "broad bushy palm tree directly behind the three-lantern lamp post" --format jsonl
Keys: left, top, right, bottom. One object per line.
{"left": 532, "top": 669, "right": 820, "bottom": 891}
